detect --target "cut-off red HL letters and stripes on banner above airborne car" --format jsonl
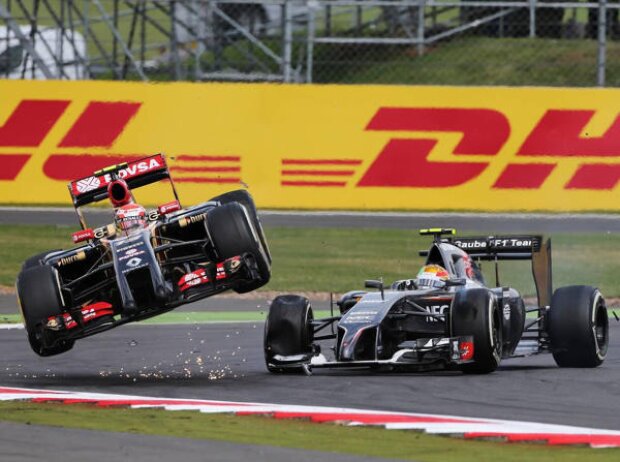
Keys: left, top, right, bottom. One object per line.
{"left": 0, "top": 100, "right": 241, "bottom": 183}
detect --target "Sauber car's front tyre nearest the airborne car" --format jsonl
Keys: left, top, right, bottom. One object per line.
{"left": 263, "top": 295, "right": 314, "bottom": 374}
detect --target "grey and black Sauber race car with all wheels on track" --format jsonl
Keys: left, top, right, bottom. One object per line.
{"left": 264, "top": 229, "right": 609, "bottom": 374}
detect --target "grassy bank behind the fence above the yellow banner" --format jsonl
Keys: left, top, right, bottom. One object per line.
{"left": 314, "top": 37, "right": 620, "bottom": 86}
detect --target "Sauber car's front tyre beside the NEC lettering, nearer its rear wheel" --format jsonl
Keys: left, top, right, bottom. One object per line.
{"left": 450, "top": 289, "right": 502, "bottom": 374}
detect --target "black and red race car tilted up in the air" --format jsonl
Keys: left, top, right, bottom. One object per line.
{"left": 17, "top": 154, "right": 271, "bottom": 356}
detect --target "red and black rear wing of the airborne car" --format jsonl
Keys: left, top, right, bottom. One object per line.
{"left": 67, "top": 154, "right": 178, "bottom": 208}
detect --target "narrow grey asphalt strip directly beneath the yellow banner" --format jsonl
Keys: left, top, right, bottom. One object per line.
{"left": 0, "top": 207, "right": 620, "bottom": 233}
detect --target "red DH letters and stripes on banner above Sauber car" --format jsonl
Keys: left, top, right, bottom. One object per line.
{"left": 281, "top": 107, "right": 620, "bottom": 190}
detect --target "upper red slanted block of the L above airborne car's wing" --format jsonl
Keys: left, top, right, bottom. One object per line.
{"left": 58, "top": 101, "right": 141, "bottom": 148}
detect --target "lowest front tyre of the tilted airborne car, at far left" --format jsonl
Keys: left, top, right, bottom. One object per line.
{"left": 17, "top": 265, "right": 75, "bottom": 356}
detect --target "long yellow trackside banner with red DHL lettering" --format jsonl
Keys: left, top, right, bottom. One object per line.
{"left": 0, "top": 81, "right": 620, "bottom": 211}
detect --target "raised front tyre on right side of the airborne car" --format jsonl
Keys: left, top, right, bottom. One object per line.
{"left": 207, "top": 202, "right": 271, "bottom": 294}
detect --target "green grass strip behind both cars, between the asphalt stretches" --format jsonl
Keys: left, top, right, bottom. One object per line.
{"left": 0, "top": 225, "right": 620, "bottom": 297}
